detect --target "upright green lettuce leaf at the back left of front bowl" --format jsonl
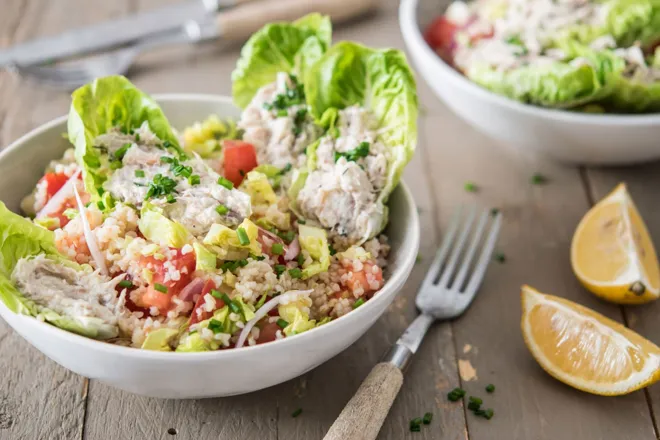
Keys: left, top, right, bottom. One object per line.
{"left": 68, "top": 76, "right": 184, "bottom": 200}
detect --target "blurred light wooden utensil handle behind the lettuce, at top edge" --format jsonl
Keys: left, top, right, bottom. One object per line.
{"left": 217, "top": 0, "right": 379, "bottom": 41}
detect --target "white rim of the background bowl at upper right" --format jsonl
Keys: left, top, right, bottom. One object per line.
{"left": 399, "top": 0, "right": 660, "bottom": 126}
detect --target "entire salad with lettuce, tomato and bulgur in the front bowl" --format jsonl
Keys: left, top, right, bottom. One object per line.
{"left": 0, "top": 14, "right": 417, "bottom": 352}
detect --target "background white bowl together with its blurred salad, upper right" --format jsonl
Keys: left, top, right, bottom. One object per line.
{"left": 400, "top": 0, "right": 660, "bottom": 164}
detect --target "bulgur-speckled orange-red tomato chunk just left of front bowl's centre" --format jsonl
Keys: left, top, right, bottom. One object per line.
{"left": 139, "top": 249, "right": 195, "bottom": 313}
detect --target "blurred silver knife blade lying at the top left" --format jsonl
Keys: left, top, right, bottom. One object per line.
{"left": 0, "top": 0, "right": 236, "bottom": 68}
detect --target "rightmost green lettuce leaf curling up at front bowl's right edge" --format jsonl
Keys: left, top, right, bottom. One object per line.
{"left": 304, "top": 42, "right": 418, "bottom": 238}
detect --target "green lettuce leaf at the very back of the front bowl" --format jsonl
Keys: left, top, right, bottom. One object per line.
{"left": 232, "top": 14, "right": 332, "bottom": 108}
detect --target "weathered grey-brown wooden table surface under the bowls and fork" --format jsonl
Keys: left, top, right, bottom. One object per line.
{"left": 0, "top": 0, "right": 660, "bottom": 440}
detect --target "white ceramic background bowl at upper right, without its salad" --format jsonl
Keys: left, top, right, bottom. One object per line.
{"left": 399, "top": 0, "right": 660, "bottom": 164}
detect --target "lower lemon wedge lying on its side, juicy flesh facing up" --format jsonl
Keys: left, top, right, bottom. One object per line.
{"left": 521, "top": 286, "right": 660, "bottom": 396}
